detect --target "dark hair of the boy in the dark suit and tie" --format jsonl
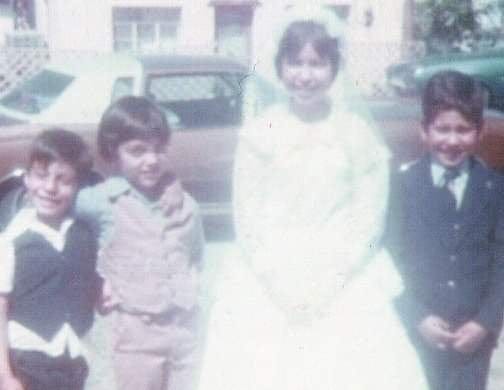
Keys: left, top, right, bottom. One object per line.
{"left": 422, "top": 70, "right": 484, "bottom": 129}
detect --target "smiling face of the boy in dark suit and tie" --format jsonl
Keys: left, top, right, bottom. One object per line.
{"left": 422, "top": 110, "right": 481, "bottom": 167}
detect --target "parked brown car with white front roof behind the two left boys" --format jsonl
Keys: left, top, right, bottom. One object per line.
{"left": 0, "top": 54, "right": 274, "bottom": 238}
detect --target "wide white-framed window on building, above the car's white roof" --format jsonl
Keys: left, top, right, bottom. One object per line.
{"left": 112, "top": 7, "right": 180, "bottom": 52}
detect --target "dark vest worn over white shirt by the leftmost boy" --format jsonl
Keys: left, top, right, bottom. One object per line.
{"left": 9, "top": 222, "right": 99, "bottom": 340}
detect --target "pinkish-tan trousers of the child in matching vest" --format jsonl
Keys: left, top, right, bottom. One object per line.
{"left": 113, "top": 311, "right": 202, "bottom": 390}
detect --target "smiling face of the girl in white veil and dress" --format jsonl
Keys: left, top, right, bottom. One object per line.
{"left": 280, "top": 43, "right": 334, "bottom": 107}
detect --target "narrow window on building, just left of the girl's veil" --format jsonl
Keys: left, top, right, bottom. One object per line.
{"left": 215, "top": 5, "right": 254, "bottom": 62}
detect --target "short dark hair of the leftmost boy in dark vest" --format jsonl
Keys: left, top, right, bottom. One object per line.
{"left": 28, "top": 128, "right": 93, "bottom": 184}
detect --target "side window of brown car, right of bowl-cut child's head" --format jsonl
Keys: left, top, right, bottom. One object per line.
{"left": 147, "top": 73, "right": 243, "bottom": 130}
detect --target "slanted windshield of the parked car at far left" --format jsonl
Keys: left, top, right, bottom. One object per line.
{"left": 0, "top": 70, "right": 74, "bottom": 114}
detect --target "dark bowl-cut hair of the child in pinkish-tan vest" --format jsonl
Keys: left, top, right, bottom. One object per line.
{"left": 97, "top": 96, "right": 171, "bottom": 161}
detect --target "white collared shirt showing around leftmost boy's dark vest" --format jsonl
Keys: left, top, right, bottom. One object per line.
{"left": 0, "top": 208, "right": 85, "bottom": 357}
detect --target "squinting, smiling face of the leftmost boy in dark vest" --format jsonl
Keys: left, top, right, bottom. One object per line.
{"left": 24, "top": 161, "right": 79, "bottom": 227}
